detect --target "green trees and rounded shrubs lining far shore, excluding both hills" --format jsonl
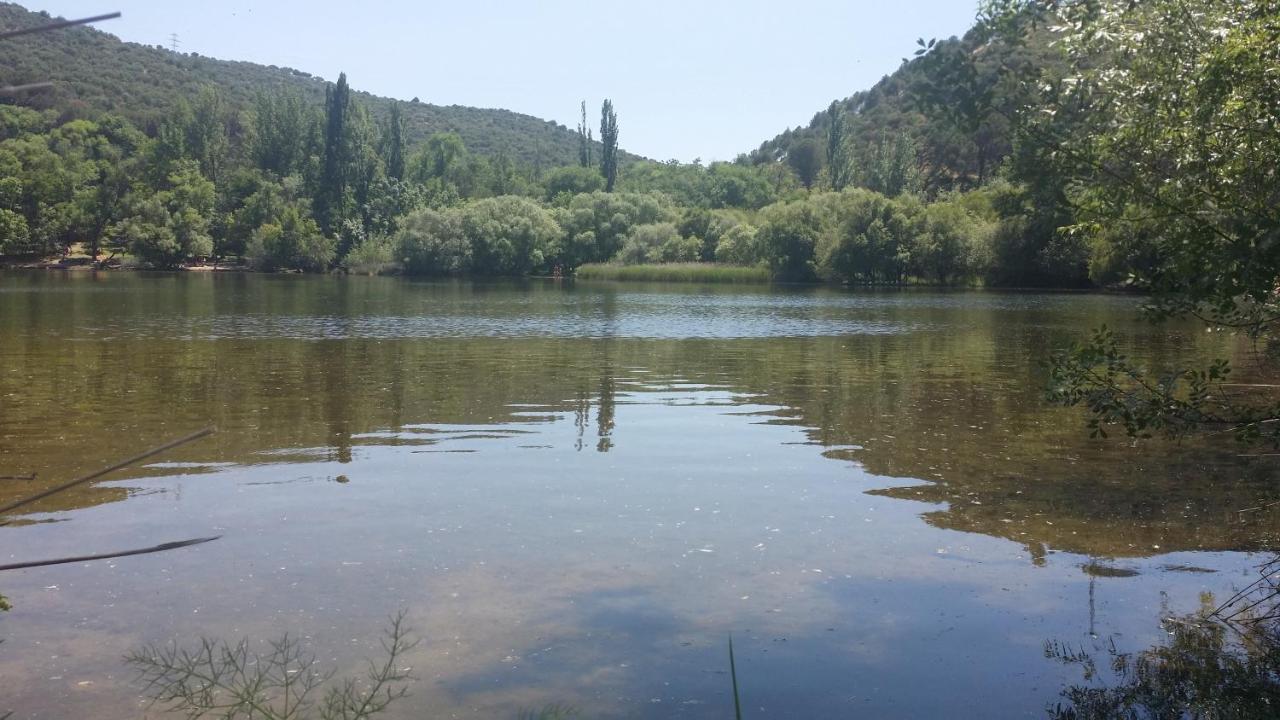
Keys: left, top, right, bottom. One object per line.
{"left": 0, "top": 70, "right": 1008, "bottom": 282}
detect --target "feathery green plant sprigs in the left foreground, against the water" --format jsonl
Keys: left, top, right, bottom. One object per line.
{"left": 127, "top": 612, "right": 417, "bottom": 720}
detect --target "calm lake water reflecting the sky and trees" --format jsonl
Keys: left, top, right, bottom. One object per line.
{"left": 0, "top": 273, "right": 1280, "bottom": 719}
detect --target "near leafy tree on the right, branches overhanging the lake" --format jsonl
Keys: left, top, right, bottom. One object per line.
{"left": 998, "top": 0, "right": 1280, "bottom": 442}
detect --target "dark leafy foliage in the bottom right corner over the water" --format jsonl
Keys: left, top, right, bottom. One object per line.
{"left": 1044, "top": 560, "right": 1280, "bottom": 720}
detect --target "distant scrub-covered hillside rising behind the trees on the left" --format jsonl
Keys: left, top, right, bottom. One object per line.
{"left": 0, "top": 3, "right": 591, "bottom": 168}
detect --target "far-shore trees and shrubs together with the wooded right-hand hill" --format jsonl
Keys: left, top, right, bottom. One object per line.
{"left": 0, "top": 3, "right": 1259, "bottom": 297}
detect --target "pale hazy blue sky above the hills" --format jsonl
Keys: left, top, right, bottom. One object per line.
{"left": 23, "top": 0, "right": 977, "bottom": 161}
